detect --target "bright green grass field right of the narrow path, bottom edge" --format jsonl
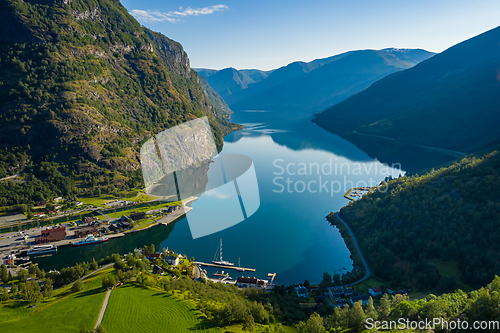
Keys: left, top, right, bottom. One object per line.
{"left": 101, "top": 284, "right": 220, "bottom": 333}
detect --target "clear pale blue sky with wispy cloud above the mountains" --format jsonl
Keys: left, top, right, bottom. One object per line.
{"left": 122, "top": 0, "right": 500, "bottom": 70}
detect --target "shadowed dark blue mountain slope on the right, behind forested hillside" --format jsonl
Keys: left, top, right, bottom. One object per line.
{"left": 314, "top": 27, "right": 500, "bottom": 153}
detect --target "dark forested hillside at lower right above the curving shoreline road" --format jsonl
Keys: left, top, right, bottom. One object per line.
{"left": 329, "top": 151, "right": 500, "bottom": 291}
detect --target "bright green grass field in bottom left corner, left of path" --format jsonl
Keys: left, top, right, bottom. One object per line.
{"left": 0, "top": 270, "right": 109, "bottom": 333}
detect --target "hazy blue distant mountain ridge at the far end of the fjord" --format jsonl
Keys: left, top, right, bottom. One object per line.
{"left": 195, "top": 48, "right": 433, "bottom": 112}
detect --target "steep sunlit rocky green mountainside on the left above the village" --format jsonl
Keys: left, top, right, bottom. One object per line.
{"left": 0, "top": 0, "right": 237, "bottom": 205}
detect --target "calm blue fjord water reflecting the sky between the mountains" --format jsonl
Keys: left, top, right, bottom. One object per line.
{"left": 34, "top": 111, "right": 404, "bottom": 284}
